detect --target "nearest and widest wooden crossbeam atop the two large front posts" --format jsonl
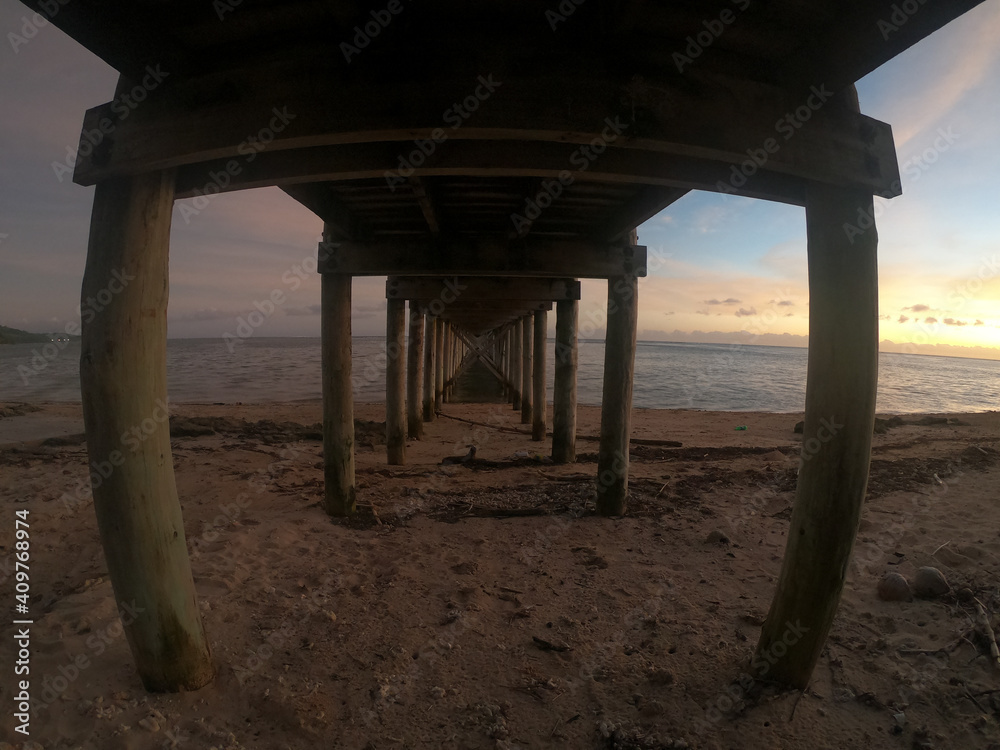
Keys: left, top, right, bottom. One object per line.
{"left": 74, "top": 66, "right": 899, "bottom": 196}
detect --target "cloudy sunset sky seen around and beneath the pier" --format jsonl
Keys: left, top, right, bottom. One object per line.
{"left": 0, "top": 0, "right": 1000, "bottom": 359}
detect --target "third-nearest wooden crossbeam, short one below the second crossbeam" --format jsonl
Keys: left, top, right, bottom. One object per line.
{"left": 385, "top": 276, "right": 580, "bottom": 304}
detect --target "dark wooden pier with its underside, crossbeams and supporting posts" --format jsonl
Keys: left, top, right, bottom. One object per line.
{"left": 19, "top": 0, "right": 978, "bottom": 690}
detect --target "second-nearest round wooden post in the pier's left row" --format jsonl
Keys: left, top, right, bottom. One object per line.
{"left": 320, "top": 273, "right": 357, "bottom": 516}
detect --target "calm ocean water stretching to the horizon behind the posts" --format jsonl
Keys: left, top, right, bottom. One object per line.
{"left": 0, "top": 337, "right": 1000, "bottom": 414}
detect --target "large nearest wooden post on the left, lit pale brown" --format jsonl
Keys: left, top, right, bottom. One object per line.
{"left": 80, "top": 172, "right": 214, "bottom": 692}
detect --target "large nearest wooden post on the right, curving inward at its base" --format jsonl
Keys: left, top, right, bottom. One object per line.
{"left": 753, "top": 185, "right": 878, "bottom": 690}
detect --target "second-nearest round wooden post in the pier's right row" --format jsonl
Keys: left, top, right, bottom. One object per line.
{"left": 597, "top": 276, "right": 639, "bottom": 516}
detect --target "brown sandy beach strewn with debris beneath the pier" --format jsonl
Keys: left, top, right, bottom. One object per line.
{"left": 0, "top": 403, "right": 1000, "bottom": 750}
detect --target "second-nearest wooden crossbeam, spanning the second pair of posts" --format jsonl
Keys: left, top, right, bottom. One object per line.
{"left": 319, "top": 241, "right": 646, "bottom": 279}
